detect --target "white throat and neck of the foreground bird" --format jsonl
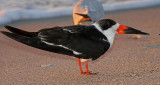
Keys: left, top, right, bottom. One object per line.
{"left": 93, "top": 23, "right": 120, "bottom": 47}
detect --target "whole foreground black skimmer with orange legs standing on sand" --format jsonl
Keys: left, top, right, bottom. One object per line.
{"left": 1, "top": 19, "right": 149, "bottom": 75}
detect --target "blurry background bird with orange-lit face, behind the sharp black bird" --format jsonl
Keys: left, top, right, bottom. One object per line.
{"left": 73, "top": 0, "right": 104, "bottom": 25}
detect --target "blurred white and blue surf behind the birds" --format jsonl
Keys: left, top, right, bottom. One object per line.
{"left": 0, "top": 0, "right": 160, "bottom": 25}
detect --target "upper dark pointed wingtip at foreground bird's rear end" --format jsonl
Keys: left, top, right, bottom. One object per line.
{"left": 2, "top": 25, "right": 38, "bottom": 37}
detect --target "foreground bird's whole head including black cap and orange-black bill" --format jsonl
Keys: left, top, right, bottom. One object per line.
{"left": 94, "top": 19, "right": 149, "bottom": 35}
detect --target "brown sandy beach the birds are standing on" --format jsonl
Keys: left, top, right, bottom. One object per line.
{"left": 0, "top": 7, "right": 160, "bottom": 85}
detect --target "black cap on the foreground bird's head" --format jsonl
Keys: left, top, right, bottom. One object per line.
{"left": 98, "top": 19, "right": 116, "bottom": 30}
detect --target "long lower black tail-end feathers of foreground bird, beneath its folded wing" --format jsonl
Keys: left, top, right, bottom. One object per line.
{"left": 0, "top": 31, "right": 73, "bottom": 56}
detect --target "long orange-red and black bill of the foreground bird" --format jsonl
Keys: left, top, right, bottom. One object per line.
{"left": 117, "top": 25, "right": 149, "bottom": 35}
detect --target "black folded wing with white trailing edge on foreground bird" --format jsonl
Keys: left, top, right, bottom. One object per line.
{"left": 38, "top": 26, "right": 109, "bottom": 56}
